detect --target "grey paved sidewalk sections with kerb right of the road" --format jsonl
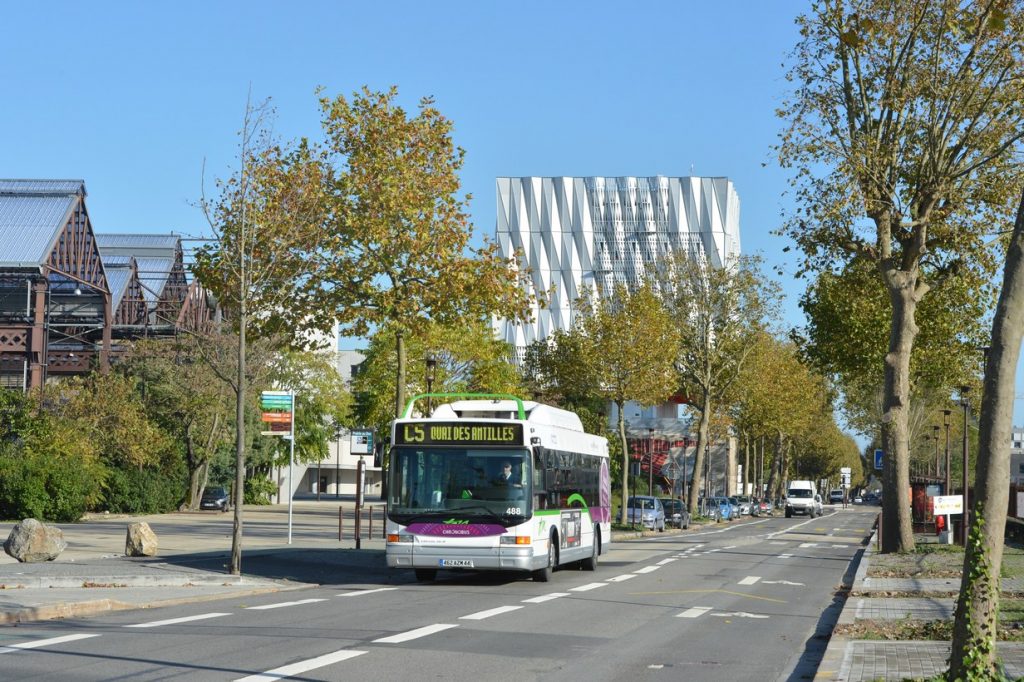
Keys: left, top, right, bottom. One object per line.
{"left": 814, "top": 536, "right": 1024, "bottom": 682}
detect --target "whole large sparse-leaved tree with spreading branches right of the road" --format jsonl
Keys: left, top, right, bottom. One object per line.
{"left": 778, "top": 0, "right": 1024, "bottom": 552}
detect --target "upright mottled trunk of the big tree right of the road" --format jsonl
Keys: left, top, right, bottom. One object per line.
{"left": 882, "top": 269, "right": 919, "bottom": 552}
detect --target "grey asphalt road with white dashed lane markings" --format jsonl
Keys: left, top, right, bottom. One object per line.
{"left": 0, "top": 501, "right": 877, "bottom": 682}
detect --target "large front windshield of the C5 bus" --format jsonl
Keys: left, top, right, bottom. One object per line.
{"left": 388, "top": 445, "right": 532, "bottom": 525}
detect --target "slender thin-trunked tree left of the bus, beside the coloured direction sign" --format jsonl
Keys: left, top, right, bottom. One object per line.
{"left": 193, "top": 95, "right": 324, "bottom": 576}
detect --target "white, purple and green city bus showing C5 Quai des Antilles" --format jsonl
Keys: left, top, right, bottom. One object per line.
{"left": 385, "top": 393, "right": 611, "bottom": 582}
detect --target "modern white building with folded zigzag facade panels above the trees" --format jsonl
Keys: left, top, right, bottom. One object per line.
{"left": 496, "top": 175, "right": 739, "bottom": 349}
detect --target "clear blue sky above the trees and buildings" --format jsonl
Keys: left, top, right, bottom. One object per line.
{"left": 0, "top": 0, "right": 1022, "bottom": 430}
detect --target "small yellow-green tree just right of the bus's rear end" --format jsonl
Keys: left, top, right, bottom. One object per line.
{"left": 558, "top": 285, "right": 678, "bottom": 524}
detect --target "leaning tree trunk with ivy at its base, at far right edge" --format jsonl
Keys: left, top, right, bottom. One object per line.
{"left": 948, "top": 188, "right": 1024, "bottom": 679}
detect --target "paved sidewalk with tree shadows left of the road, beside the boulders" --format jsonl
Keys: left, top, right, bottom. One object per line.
{"left": 0, "top": 500, "right": 387, "bottom": 624}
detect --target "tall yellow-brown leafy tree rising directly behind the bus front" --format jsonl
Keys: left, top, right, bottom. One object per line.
{"left": 305, "top": 87, "right": 531, "bottom": 425}
